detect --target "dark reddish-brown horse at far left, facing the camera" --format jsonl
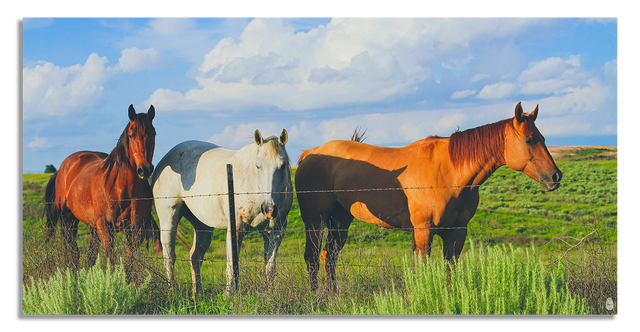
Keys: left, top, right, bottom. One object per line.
{"left": 45, "top": 105, "right": 162, "bottom": 272}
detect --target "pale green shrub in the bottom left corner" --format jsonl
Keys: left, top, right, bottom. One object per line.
{"left": 22, "top": 257, "right": 151, "bottom": 315}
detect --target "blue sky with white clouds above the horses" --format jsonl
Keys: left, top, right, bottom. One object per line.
{"left": 22, "top": 15, "right": 620, "bottom": 173}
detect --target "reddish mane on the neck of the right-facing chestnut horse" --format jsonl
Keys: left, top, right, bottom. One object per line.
{"left": 449, "top": 119, "right": 512, "bottom": 168}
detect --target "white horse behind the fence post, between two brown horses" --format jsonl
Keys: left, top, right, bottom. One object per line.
{"left": 152, "top": 129, "right": 293, "bottom": 297}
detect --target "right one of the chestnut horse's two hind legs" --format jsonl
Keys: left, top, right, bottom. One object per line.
{"left": 322, "top": 204, "right": 353, "bottom": 291}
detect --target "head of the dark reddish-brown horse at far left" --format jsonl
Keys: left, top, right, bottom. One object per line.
{"left": 127, "top": 105, "right": 156, "bottom": 180}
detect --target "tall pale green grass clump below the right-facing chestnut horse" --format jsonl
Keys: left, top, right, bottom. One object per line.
{"left": 353, "top": 244, "right": 591, "bottom": 315}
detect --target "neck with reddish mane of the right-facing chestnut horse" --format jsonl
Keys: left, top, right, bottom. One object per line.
{"left": 449, "top": 120, "right": 509, "bottom": 185}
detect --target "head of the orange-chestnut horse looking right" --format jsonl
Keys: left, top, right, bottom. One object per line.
{"left": 504, "top": 103, "right": 562, "bottom": 191}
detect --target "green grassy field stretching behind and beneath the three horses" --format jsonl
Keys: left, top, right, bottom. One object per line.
{"left": 22, "top": 149, "right": 620, "bottom": 314}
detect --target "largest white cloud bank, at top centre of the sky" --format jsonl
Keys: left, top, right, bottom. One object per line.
{"left": 146, "top": 16, "right": 555, "bottom": 111}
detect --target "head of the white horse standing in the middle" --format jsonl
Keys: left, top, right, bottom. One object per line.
{"left": 251, "top": 129, "right": 291, "bottom": 228}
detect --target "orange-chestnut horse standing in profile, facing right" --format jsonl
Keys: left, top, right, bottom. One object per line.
{"left": 295, "top": 103, "right": 562, "bottom": 289}
